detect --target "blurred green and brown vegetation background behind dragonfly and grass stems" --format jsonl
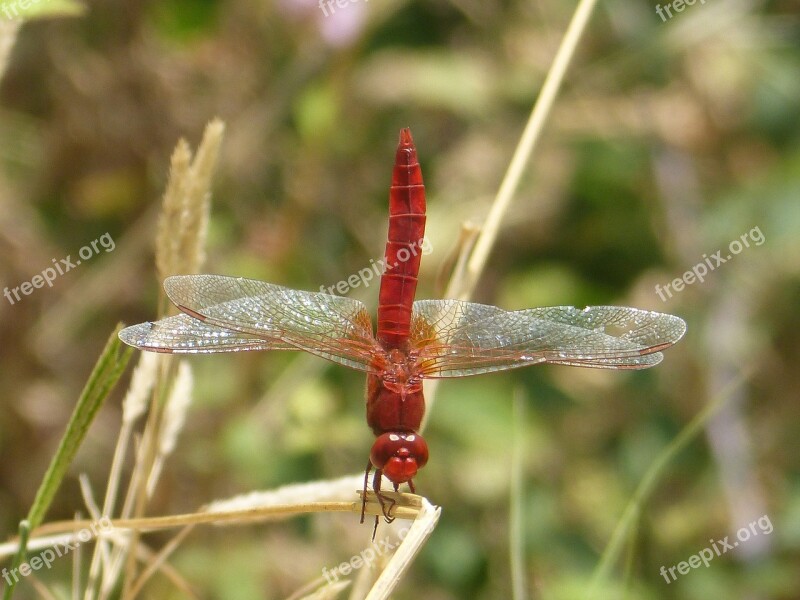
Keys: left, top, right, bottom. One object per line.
{"left": 0, "top": 0, "right": 800, "bottom": 599}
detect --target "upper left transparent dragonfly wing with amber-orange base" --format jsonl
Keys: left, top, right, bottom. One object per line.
{"left": 119, "top": 275, "right": 384, "bottom": 371}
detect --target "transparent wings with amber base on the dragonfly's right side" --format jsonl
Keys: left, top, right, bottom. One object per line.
{"left": 411, "top": 300, "right": 686, "bottom": 377}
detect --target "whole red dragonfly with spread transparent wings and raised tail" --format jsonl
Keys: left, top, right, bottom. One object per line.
{"left": 119, "top": 129, "right": 686, "bottom": 525}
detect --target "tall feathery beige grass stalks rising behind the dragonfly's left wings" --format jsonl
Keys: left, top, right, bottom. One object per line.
{"left": 77, "top": 120, "right": 224, "bottom": 600}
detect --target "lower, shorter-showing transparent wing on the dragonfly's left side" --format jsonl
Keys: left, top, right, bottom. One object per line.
{"left": 119, "top": 314, "right": 297, "bottom": 354}
